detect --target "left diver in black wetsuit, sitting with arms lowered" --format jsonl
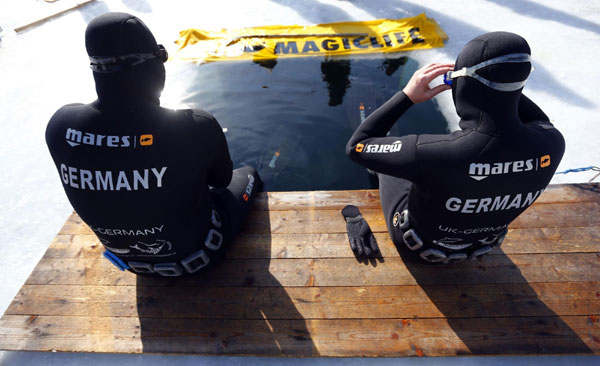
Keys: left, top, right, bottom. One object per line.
{"left": 46, "top": 13, "right": 261, "bottom": 276}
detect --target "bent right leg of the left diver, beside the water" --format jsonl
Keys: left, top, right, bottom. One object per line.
{"left": 211, "top": 166, "right": 262, "bottom": 240}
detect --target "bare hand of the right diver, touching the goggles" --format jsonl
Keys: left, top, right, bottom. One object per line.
{"left": 402, "top": 63, "right": 454, "bottom": 104}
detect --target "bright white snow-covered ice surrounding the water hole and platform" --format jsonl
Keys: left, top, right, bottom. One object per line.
{"left": 0, "top": 0, "right": 600, "bottom": 364}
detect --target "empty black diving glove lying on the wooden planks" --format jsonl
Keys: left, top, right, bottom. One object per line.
{"left": 342, "top": 205, "right": 379, "bottom": 257}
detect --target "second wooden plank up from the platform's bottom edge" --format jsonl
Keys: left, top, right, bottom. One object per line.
{"left": 6, "top": 282, "right": 600, "bottom": 319}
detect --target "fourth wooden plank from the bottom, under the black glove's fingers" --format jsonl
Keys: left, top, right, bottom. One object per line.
{"left": 44, "top": 227, "right": 600, "bottom": 259}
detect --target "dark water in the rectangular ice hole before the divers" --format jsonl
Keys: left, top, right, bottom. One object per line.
{"left": 167, "top": 57, "right": 448, "bottom": 191}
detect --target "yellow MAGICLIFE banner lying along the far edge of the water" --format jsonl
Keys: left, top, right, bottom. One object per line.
{"left": 174, "top": 13, "right": 448, "bottom": 63}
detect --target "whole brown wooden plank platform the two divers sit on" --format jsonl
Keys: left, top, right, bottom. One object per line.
{"left": 0, "top": 184, "right": 600, "bottom": 357}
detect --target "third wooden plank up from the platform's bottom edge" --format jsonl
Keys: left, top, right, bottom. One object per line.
{"left": 26, "top": 253, "right": 600, "bottom": 287}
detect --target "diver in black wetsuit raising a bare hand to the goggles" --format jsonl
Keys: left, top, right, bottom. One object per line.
{"left": 346, "top": 32, "right": 565, "bottom": 263}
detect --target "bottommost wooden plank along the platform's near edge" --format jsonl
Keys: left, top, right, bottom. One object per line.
{"left": 0, "top": 314, "right": 600, "bottom": 357}
